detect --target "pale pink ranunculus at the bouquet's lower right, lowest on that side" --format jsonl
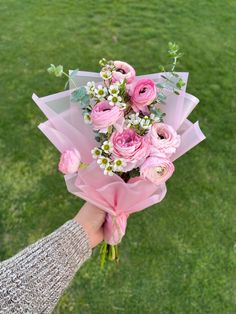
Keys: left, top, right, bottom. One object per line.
{"left": 140, "top": 157, "right": 175, "bottom": 185}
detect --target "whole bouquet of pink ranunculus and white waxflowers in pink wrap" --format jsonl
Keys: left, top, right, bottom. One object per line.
{"left": 33, "top": 43, "right": 205, "bottom": 264}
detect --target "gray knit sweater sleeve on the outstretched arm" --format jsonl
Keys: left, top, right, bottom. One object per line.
{"left": 0, "top": 220, "right": 91, "bottom": 314}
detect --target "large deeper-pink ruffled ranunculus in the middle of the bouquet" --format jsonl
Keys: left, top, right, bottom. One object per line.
{"left": 110, "top": 129, "right": 150, "bottom": 171}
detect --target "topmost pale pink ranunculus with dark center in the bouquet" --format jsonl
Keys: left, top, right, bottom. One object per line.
{"left": 112, "top": 61, "right": 135, "bottom": 83}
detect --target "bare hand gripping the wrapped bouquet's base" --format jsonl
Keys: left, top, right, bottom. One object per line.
{"left": 74, "top": 202, "right": 106, "bottom": 248}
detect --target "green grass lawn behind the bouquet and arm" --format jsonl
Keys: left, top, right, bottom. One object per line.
{"left": 0, "top": 0, "right": 236, "bottom": 314}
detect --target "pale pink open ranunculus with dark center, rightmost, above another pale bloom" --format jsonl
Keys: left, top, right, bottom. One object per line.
{"left": 149, "top": 123, "right": 180, "bottom": 157}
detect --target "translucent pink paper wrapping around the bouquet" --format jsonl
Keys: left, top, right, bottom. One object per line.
{"left": 32, "top": 71, "right": 205, "bottom": 245}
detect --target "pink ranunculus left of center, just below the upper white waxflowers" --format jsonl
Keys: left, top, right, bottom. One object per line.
{"left": 90, "top": 100, "right": 124, "bottom": 130}
